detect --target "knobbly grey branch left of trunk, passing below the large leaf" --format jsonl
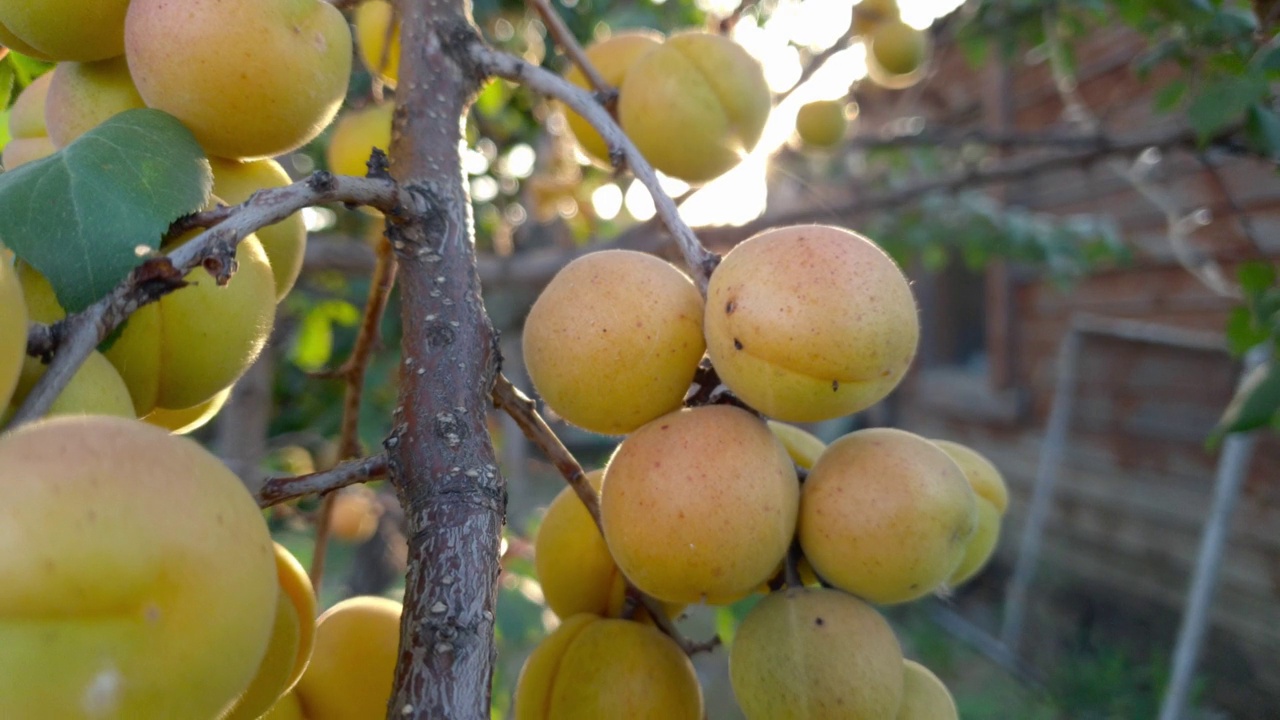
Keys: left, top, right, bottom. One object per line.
{"left": 12, "top": 172, "right": 415, "bottom": 427}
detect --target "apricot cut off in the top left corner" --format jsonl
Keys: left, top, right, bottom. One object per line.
{"left": 0, "top": 0, "right": 129, "bottom": 61}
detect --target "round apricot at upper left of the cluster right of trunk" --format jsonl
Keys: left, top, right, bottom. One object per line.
{"left": 524, "top": 250, "right": 705, "bottom": 434}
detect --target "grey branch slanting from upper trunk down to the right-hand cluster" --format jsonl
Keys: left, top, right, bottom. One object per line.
{"left": 470, "top": 42, "right": 719, "bottom": 288}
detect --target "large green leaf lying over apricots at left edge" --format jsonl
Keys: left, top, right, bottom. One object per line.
{"left": 0, "top": 110, "right": 212, "bottom": 313}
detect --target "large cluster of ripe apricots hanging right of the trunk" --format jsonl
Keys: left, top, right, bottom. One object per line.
{"left": 516, "top": 225, "right": 1007, "bottom": 720}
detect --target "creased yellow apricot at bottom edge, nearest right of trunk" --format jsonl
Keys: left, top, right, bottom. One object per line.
{"left": 515, "top": 614, "right": 703, "bottom": 720}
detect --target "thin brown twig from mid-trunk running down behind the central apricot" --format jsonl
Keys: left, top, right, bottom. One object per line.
{"left": 493, "top": 374, "right": 719, "bottom": 653}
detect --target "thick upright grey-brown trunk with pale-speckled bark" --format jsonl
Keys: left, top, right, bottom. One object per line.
{"left": 385, "top": 0, "right": 506, "bottom": 720}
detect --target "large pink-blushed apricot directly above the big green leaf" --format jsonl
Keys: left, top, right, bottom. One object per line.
{"left": 124, "top": 0, "right": 352, "bottom": 160}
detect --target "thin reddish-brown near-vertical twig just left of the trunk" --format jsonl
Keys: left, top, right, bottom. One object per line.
{"left": 308, "top": 237, "right": 397, "bottom": 592}
